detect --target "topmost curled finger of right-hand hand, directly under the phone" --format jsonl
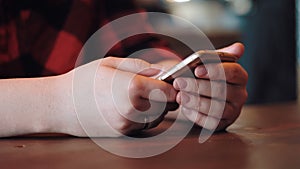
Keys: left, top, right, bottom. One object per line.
{"left": 194, "top": 63, "right": 248, "bottom": 86}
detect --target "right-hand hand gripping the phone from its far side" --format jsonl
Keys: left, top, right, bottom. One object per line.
{"left": 173, "top": 43, "right": 248, "bottom": 131}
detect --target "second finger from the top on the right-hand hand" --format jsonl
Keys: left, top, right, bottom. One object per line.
{"left": 174, "top": 78, "right": 247, "bottom": 103}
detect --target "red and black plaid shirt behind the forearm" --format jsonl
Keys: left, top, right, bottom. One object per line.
{"left": 0, "top": 0, "right": 178, "bottom": 78}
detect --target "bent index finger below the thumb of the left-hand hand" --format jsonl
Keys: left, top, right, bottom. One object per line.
{"left": 129, "top": 75, "right": 177, "bottom": 102}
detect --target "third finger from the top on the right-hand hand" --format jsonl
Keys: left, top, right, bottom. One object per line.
{"left": 177, "top": 92, "right": 240, "bottom": 121}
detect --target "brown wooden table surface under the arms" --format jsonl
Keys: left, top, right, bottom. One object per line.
{"left": 0, "top": 103, "right": 300, "bottom": 169}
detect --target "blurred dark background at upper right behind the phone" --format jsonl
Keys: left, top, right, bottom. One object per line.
{"left": 136, "top": 0, "right": 299, "bottom": 104}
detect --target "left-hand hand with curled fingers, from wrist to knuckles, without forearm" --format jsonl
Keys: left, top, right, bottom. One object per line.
{"left": 62, "top": 57, "right": 177, "bottom": 137}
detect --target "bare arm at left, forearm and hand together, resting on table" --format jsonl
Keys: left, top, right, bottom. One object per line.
{"left": 0, "top": 57, "right": 176, "bottom": 137}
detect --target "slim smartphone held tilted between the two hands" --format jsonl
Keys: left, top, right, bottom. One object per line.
{"left": 157, "top": 50, "right": 238, "bottom": 82}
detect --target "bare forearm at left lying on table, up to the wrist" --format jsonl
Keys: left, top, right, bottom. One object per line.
{"left": 0, "top": 76, "right": 75, "bottom": 137}
